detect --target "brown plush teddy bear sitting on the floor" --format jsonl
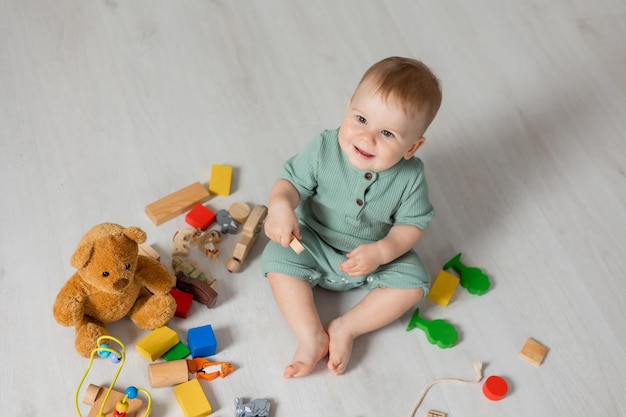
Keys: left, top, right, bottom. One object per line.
{"left": 53, "top": 223, "right": 176, "bottom": 357}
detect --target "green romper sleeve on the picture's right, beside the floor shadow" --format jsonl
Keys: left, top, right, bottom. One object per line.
{"left": 394, "top": 158, "right": 435, "bottom": 230}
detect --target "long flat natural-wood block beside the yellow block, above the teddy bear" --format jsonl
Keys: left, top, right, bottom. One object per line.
{"left": 146, "top": 182, "right": 211, "bottom": 226}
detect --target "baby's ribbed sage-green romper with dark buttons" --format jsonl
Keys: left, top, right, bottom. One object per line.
{"left": 262, "top": 129, "right": 435, "bottom": 294}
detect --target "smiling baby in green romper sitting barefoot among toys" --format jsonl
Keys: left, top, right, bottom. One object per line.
{"left": 262, "top": 57, "right": 441, "bottom": 378}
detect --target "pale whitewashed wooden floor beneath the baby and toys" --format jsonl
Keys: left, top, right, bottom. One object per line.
{"left": 0, "top": 0, "right": 626, "bottom": 417}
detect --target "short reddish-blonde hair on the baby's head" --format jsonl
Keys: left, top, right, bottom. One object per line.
{"left": 355, "top": 56, "right": 441, "bottom": 130}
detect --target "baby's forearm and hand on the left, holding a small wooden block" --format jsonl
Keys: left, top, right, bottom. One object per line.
{"left": 264, "top": 179, "right": 302, "bottom": 248}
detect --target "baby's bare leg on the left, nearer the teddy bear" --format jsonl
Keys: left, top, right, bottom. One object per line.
{"left": 267, "top": 273, "right": 328, "bottom": 378}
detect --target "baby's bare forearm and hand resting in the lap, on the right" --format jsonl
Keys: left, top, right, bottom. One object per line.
{"left": 339, "top": 224, "right": 424, "bottom": 277}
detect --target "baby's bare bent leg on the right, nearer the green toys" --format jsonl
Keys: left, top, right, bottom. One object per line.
{"left": 326, "top": 288, "right": 424, "bottom": 375}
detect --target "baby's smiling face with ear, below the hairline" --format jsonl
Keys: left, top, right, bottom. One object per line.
{"left": 339, "top": 80, "right": 424, "bottom": 172}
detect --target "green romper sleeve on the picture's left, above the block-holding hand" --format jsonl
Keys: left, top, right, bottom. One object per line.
{"left": 279, "top": 135, "right": 322, "bottom": 200}
